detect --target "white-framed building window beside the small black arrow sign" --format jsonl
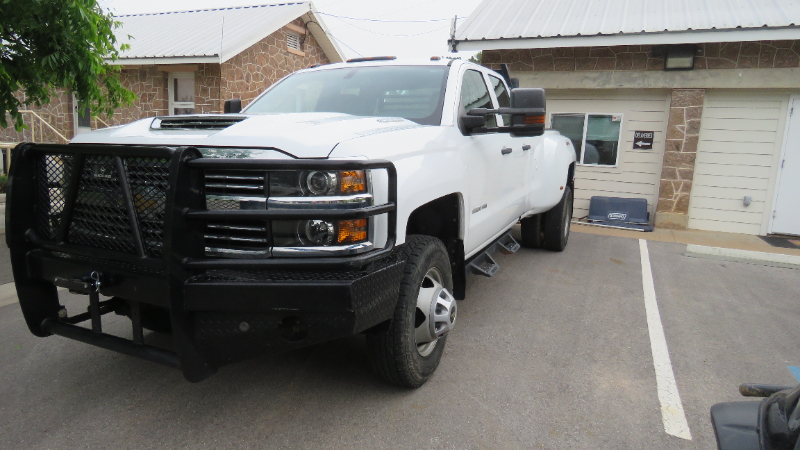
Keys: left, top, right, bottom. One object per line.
{"left": 550, "top": 113, "right": 622, "bottom": 166}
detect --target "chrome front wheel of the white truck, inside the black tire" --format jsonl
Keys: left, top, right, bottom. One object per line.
{"left": 414, "top": 267, "right": 457, "bottom": 356}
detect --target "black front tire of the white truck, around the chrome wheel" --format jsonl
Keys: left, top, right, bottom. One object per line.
{"left": 367, "top": 235, "right": 453, "bottom": 388}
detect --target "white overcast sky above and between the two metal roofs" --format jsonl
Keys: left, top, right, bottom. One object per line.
{"left": 99, "top": 0, "right": 481, "bottom": 58}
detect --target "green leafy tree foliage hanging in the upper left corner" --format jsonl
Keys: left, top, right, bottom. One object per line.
{"left": 0, "top": 0, "right": 136, "bottom": 131}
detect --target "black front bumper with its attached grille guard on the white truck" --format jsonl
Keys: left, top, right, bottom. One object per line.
{"left": 6, "top": 146, "right": 403, "bottom": 381}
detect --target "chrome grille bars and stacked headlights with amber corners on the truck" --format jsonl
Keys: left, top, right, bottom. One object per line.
{"left": 205, "top": 166, "right": 374, "bottom": 257}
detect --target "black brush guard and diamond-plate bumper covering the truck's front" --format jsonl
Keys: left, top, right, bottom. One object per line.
{"left": 6, "top": 144, "right": 403, "bottom": 381}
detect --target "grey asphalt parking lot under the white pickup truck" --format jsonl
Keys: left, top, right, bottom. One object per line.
{"left": 0, "top": 233, "right": 800, "bottom": 449}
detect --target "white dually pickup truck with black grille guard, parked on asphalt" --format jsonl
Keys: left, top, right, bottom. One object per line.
{"left": 6, "top": 58, "right": 575, "bottom": 387}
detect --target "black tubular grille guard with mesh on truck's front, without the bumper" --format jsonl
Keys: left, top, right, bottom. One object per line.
{"left": 6, "top": 144, "right": 399, "bottom": 381}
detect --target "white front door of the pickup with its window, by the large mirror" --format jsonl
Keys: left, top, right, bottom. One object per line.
{"left": 460, "top": 69, "right": 522, "bottom": 256}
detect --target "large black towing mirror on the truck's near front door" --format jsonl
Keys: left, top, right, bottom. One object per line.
{"left": 467, "top": 88, "right": 546, "bottom": 136}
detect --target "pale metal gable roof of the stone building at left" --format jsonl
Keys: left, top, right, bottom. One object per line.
{"left": 114, "top": 1, "right": 343, "bottom": 64}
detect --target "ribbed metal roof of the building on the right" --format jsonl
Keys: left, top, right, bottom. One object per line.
{"left": 455, "top": 0, "right": 800, "bottom": 50}
